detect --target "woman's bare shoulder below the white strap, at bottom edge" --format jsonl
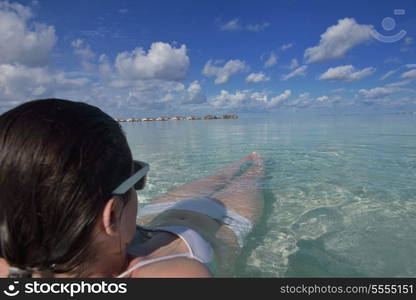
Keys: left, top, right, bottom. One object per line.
{"left": 131, "top": 257, "right": 212, "bottom": 278}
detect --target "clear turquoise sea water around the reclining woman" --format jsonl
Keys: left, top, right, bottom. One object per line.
{"left": 123, "top": 115, "right": 416, "bottom": 277}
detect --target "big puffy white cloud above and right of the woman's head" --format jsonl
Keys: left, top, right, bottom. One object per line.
{"left": 115, "top": 42, "right": 189, "bottom": 81}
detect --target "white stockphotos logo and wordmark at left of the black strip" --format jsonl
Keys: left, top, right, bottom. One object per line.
{"left": 3, "top": 280, "right": 127, "bottom": 297}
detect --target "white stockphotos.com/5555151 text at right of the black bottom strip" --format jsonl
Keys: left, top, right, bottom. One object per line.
{"left": 280, "top": 284, "right": 414, "bottom": 295}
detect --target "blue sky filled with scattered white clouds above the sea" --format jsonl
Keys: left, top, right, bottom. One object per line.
{"left": 0, "top": 0, "right": 416, "bottom": 117}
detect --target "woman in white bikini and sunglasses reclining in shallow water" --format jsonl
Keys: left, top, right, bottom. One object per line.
{"left": 0, "top": 99, "right": 264, "bottom": 277}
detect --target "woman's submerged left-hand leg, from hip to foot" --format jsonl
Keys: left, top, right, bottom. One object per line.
{"left": 147, "top": 152, "right": 257, "bottom": 203}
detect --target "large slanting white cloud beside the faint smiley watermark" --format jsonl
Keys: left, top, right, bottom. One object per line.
{"left": 304, "top": 18, "right": 372, "bottom": 63}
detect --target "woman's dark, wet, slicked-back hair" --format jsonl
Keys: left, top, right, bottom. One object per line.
{"left": 0, "top": 99, "right": 132, "bottom": 276}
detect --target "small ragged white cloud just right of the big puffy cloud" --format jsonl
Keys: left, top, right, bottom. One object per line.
{"left": 202, "top": 59, "right": 248, "bottom": 84}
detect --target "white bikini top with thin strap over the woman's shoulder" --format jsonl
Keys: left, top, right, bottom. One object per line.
{"left": 117, "top": 226, "right": 214, "bottom": 278}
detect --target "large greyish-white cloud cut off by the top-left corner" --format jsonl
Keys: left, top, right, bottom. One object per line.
{"left": 0, "top": 1, "right": 57, "bottom": 66}
